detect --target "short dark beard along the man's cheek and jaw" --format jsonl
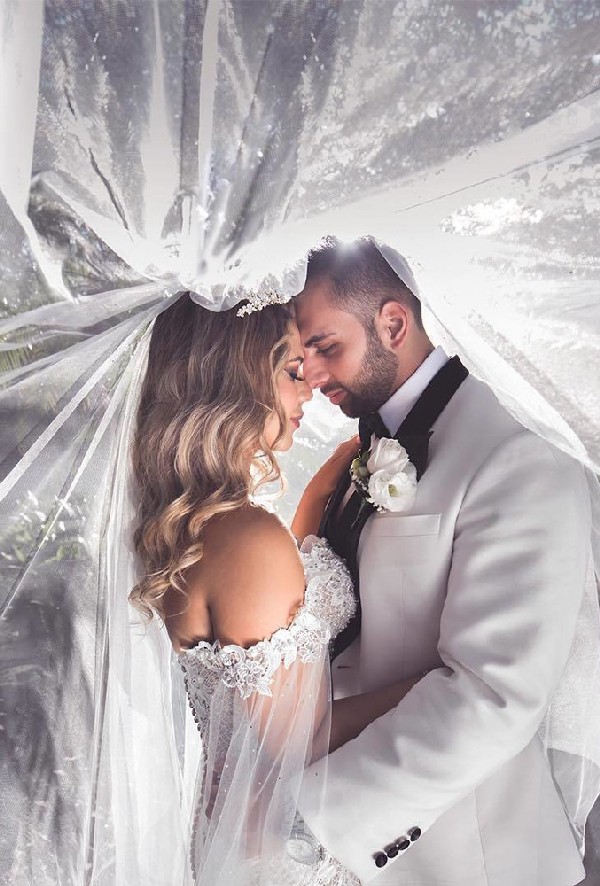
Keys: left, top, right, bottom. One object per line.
{"left": 338, "top": 328, "right": 398, "bottom": 418}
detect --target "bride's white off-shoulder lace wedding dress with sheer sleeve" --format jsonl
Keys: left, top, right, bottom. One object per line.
{"left": 179, "top": 537, "right": 359, "bottom": 886}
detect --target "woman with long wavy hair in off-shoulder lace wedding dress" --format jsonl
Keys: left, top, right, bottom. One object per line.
{"left": 130, "top": 293, "right": 414, "bottom": 886}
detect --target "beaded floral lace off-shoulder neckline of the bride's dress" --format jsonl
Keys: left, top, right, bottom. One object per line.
{"left": 179, "top": 536, "right": 356, "bottom": 704}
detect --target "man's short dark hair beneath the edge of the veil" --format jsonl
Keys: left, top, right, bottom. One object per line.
{"left": 306, "top": 237, "right": 423, "bottom": 329}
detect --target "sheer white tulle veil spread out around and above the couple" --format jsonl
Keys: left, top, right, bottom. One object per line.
{"left": 0, "top": 0, "right": 600, "bottom": 886}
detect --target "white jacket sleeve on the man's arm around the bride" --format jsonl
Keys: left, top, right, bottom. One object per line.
{"left": 299, "top": 431, "right": 591, "bottom": 881}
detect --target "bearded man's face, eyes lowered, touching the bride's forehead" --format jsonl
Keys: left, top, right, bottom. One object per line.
{"left": 296, "top": 279, "right": 398, "bottom": 418}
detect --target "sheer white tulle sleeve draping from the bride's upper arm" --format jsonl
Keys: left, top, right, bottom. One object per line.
{"left": 185, "top": 645, "right": 330, "bottom": 886}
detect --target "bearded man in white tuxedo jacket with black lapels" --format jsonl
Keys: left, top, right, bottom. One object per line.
{"left": 296, "top": 238, "right": 590, "bottom": 886}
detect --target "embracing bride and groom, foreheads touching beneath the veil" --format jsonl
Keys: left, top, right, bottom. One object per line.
{"left": 131, "top": 238, "right": 590, "bottom": 886}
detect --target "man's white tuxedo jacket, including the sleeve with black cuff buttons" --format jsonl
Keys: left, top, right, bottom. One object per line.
{"left": 299, "top": 377, "right": 590, "bottom": 886}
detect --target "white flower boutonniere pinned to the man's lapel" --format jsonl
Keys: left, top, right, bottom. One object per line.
{"left": 350, "top": 437, "right": 417, "bottom": 513}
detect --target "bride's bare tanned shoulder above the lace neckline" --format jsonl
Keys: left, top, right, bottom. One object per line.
{"left": 189, "top": 506, "right": 304, "bottom": 646}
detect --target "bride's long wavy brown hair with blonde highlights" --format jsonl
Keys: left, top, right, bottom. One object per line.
{"left": 129, "top": 293, "right": 292, "bottom": 620}
